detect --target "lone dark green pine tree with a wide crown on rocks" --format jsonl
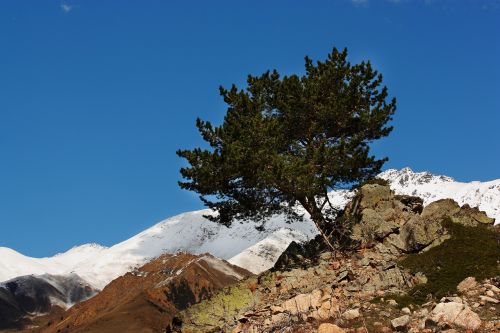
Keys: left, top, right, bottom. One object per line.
{"left": 177, "top": 48, "right": 396, "bottom": 247}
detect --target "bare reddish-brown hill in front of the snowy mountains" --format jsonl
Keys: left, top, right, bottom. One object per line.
{"left": 35, "top": 253, "right": 251, "bottom": 333}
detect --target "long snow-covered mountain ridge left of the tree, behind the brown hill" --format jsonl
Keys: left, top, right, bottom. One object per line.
{"left": 0, "top": 210, "right": 316, "bottom": 289}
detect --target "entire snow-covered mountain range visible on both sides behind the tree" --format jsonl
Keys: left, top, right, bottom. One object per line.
{"left": 0, "top": 168, "right": 500, "bottom": 289}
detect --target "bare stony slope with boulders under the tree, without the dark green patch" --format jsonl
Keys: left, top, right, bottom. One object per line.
{"left": 177, "top": 184, "right": 498, "bottom": 333}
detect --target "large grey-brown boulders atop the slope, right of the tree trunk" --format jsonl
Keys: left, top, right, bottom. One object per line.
{"left": 350, "top": 184, "right": 494, "bottom": 253}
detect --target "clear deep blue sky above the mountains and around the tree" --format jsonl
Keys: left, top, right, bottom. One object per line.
{"left": 0, "top": 0, "right": 500, "bottom": 256}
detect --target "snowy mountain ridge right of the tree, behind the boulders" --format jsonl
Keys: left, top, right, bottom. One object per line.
{"left": 378, "top": 168, "right": 500, "bottom": 224}
